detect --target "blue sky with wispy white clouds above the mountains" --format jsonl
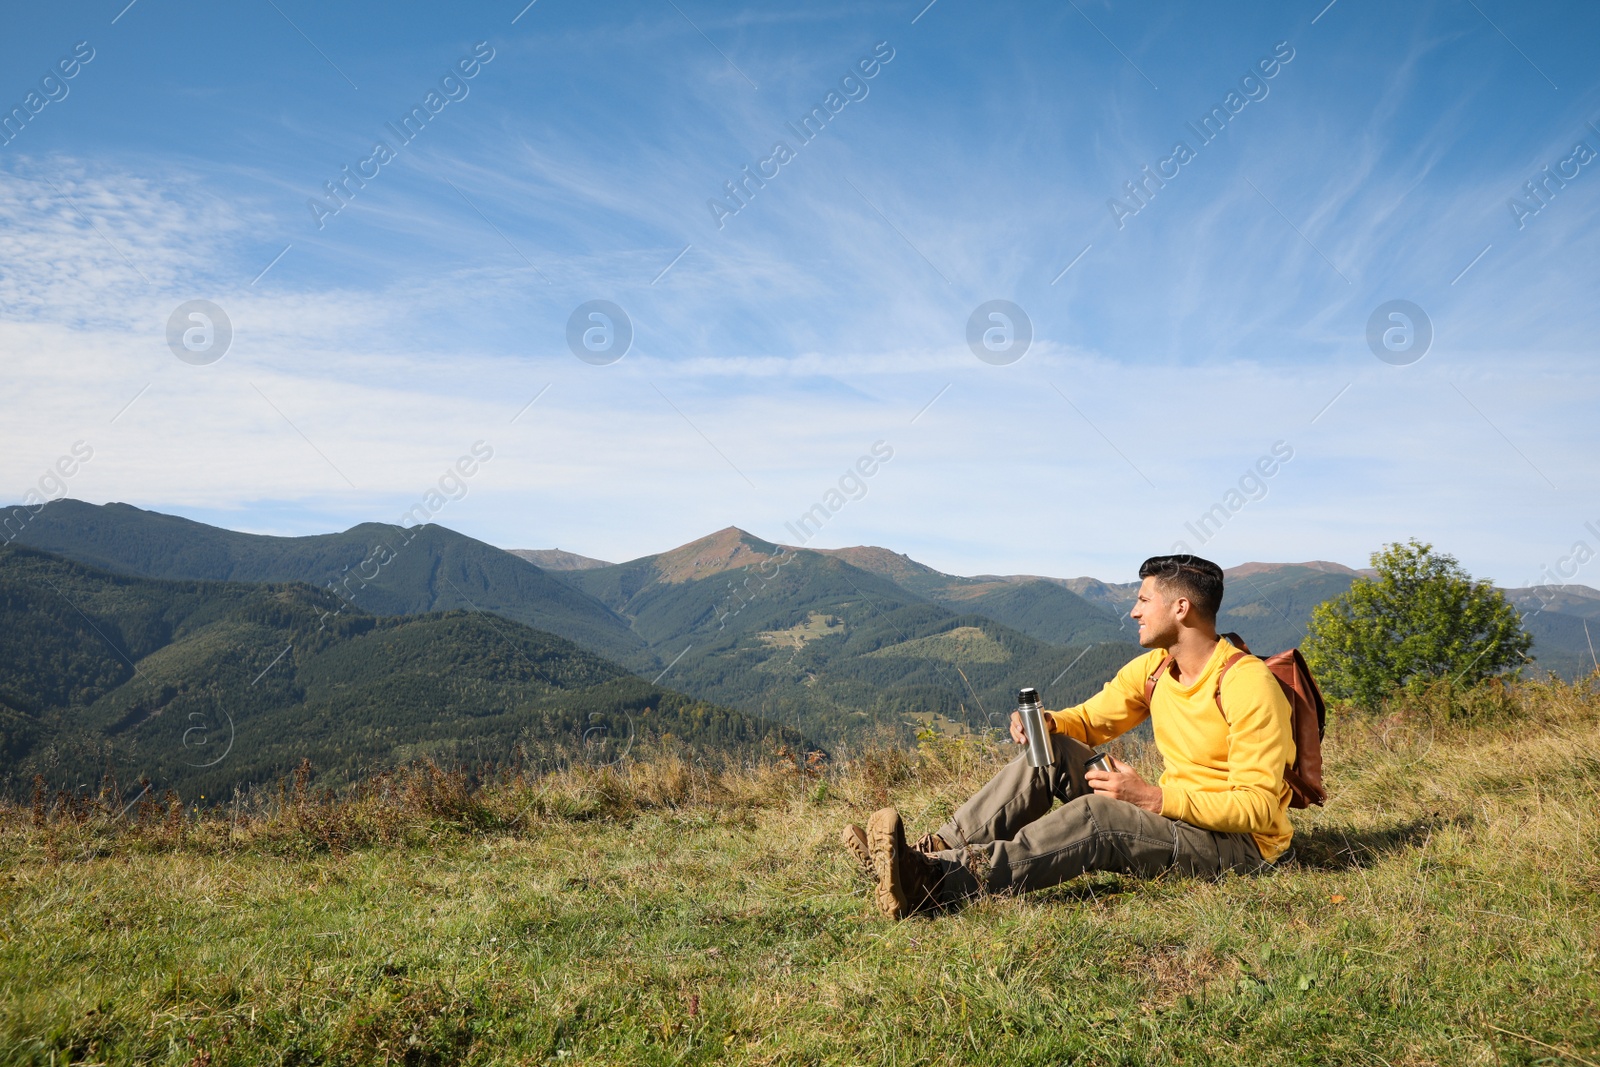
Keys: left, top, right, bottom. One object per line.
{"left": 0, "top": 0, "right": 1600, "bottom": 585}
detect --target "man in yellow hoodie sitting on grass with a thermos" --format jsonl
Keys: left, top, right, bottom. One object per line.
{"left": 843, "top": 555, "right": 1294, "bottom": 918}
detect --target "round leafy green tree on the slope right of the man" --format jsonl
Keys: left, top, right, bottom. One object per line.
{"left": 1302, "top": 539, "right": 1533, "bottom": 710}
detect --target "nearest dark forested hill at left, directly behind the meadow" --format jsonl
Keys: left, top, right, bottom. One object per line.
{"left": 0, "top": 545, "right": 805, "bottom": 797}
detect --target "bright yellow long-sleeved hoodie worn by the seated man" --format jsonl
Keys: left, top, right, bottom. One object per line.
{"left": 1051, "top": 640, "right": 1294, "bottom": 862}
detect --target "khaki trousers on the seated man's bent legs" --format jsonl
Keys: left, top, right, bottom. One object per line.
{"left": 930, "top": 734, "right": 1270, "bottom": 904}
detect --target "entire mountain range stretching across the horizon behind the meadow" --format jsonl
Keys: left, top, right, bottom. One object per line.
{"left": 0, "top": 499, "right": 1600, "bottom": 787}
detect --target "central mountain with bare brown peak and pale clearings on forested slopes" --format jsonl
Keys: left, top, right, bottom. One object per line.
{"left": 547, "top": 528, "right": 1138, "bottom": 742}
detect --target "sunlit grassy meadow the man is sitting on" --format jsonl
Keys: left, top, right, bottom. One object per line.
{"left": 0, "top": 686, "right": 1600, "bottom": 1067}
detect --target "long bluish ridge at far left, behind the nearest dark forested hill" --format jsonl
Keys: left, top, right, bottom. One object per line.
{"left": 7, "top": 501, "right": 651, "bottom": 670}
